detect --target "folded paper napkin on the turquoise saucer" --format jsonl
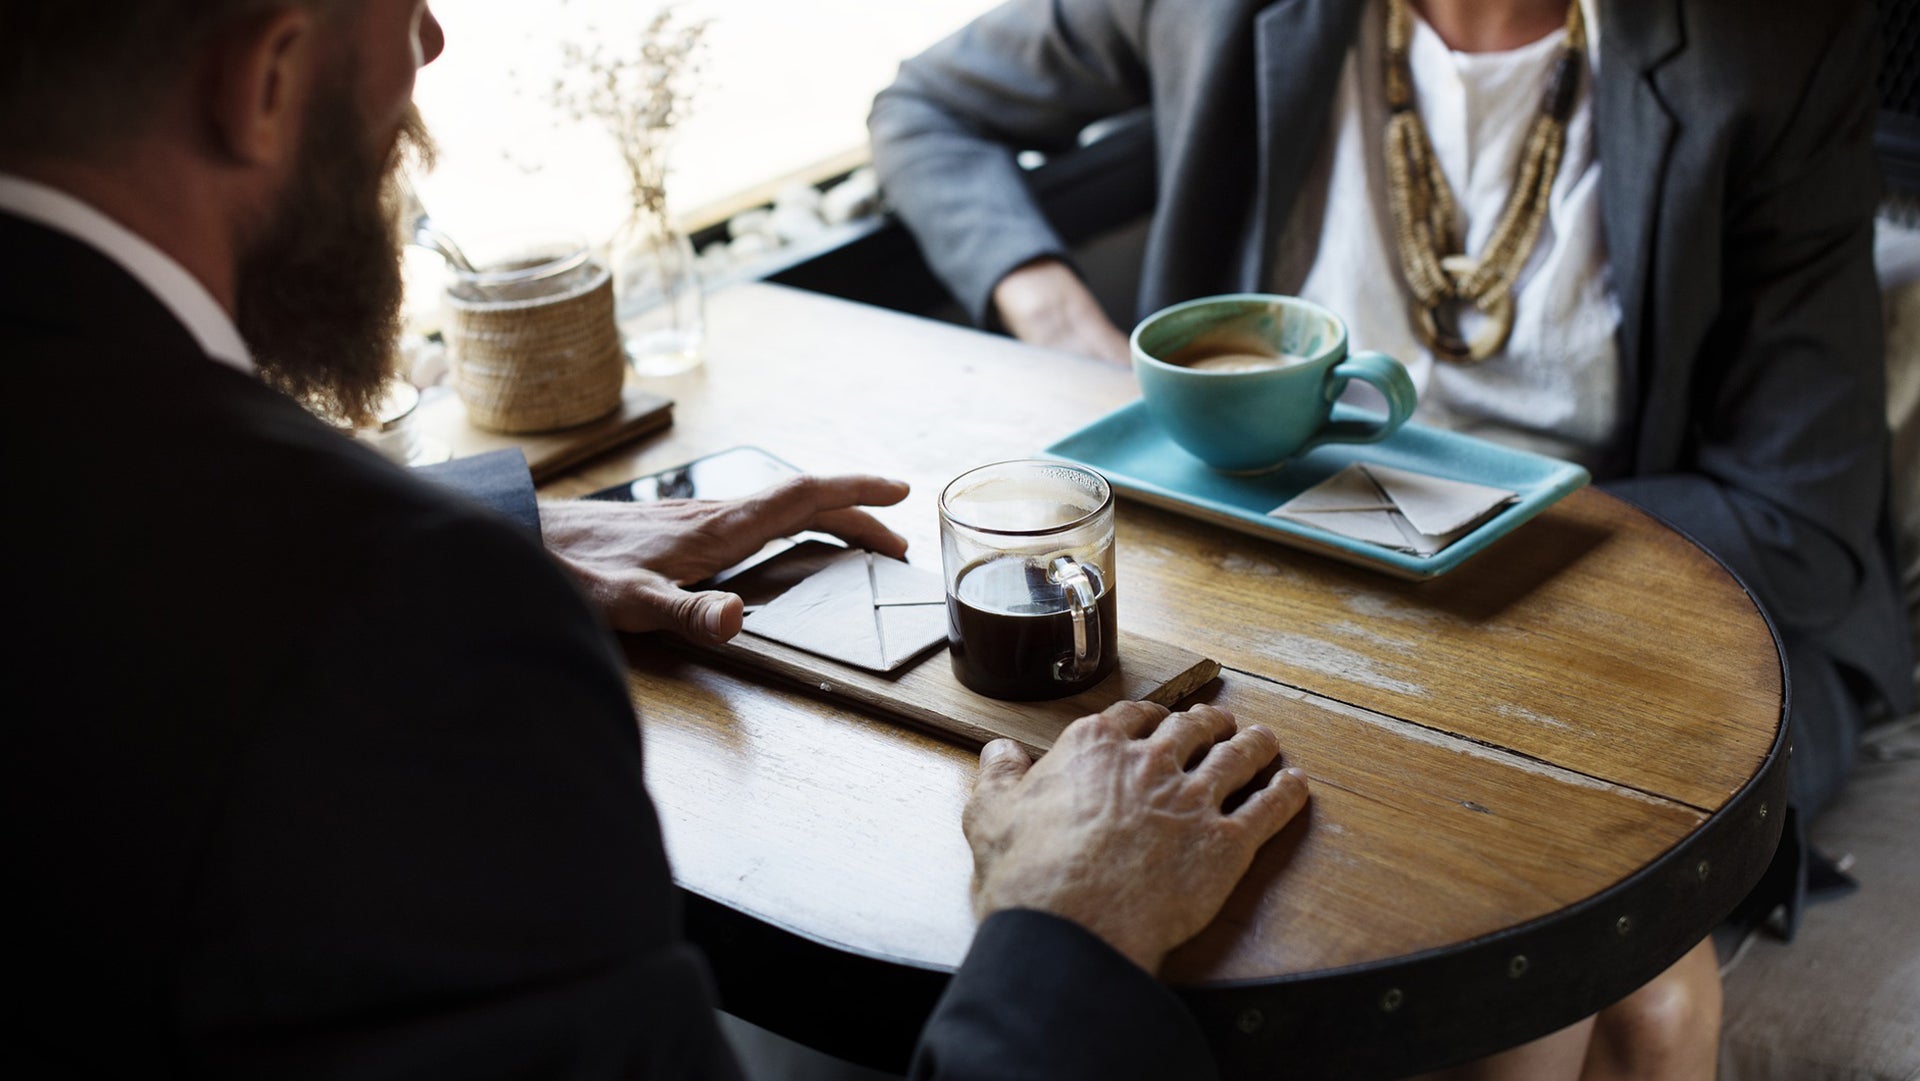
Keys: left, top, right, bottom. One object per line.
{"left": 1267, "top": 463, "right": 1515, "bottom": 555}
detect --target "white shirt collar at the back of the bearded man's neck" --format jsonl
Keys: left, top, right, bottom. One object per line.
{"left": 0, "top": 173, "right": 253, "bottom": 374}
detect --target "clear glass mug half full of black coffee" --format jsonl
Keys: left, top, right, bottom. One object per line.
{"left": 941, "top": 459, "right": 1119, "bottom": 701}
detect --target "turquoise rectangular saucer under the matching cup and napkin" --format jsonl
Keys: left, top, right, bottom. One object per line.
{"left": 1044, "top": 401, "right": 1588, "bottom": 580}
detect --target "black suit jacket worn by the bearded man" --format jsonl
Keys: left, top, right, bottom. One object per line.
{"left": 0, "top": 215, "right": 1210, "bottom": 1079}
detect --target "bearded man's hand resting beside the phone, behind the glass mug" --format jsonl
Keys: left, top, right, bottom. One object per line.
{"left": 540, "top": 476, "right": 906, "bottom": 641}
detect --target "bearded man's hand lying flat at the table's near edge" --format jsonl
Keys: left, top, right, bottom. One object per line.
{"left": 962, "top": 703, "right": 1308, "bottom": 972}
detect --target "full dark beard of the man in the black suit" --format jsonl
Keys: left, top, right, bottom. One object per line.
{"left": 236, "top": 71, "right": 432, "bottom": 424}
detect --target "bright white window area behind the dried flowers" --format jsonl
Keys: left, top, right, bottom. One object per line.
{"left": 415, "top": 0, "right": 995, "bottom": 240}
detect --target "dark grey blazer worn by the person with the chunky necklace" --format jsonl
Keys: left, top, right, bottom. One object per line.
{"left": 870, "top": 0, "right": 1910, "bottom": 821}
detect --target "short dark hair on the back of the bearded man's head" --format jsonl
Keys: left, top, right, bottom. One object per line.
{"left": 0, "top": 0, "right": 336, "bottom": 161}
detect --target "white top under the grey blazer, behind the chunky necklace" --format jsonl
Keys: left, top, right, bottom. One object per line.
{"left": 1269, "top": 0, "right": 1620, "bottom": 467}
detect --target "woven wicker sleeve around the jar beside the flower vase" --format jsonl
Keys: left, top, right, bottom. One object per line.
{"left": 445, "top": 263, "right": 626, "bottom": 434}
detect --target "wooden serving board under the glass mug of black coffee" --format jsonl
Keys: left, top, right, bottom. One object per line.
{"left": 691, "top": 628, "right": 1219, "bottom": 757}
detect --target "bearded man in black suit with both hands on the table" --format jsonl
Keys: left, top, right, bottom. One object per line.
{"left": 0, "top": 0, "right": 1306, "bottom": 1077}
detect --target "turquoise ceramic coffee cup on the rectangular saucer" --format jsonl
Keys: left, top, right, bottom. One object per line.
{"left": 1131, "top": 294, "right": 1417, "bottom": 474}
